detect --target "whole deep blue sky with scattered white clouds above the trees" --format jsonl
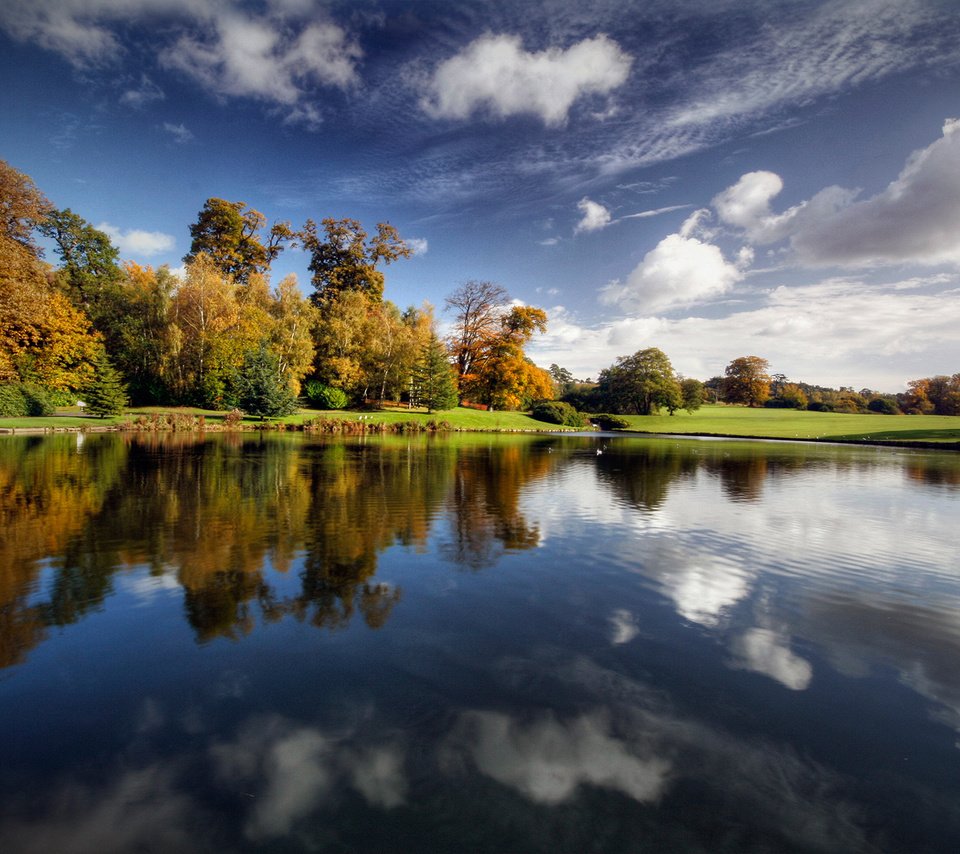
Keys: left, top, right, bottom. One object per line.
{"left": 0, "top": 0, "right": 960, "bottom": 392}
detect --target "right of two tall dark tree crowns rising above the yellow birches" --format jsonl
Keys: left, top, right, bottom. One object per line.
{"left": 296, "top": 217, "right": 413, "bottom": 306}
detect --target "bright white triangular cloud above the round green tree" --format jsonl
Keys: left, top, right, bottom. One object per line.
{"left": 600, "top": 211, "right": 743, "bottom": 313}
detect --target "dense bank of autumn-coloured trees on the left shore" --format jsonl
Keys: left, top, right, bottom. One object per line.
{"left": 0, "top": 161, "right": 552, "bottom": 416}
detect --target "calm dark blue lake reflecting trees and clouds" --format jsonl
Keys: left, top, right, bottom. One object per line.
{"left": 0, "top": 434, "right": 960, "bottom": 854}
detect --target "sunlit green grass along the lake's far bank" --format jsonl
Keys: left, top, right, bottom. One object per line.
{"left": 0, "top": 405, "right": 960, "bottom": 444}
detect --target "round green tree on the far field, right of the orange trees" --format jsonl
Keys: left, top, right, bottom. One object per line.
{"left": 597, "top": 347, "right": 683, "bottom": 415}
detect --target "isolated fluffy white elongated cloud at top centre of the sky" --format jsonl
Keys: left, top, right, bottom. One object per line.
{"left": 421, "top": 33, "right": 633, "bottom": 126}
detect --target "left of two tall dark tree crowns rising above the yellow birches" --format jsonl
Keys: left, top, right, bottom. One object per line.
{"left": 183, "top": 198, "right": 294, "bottom": 283}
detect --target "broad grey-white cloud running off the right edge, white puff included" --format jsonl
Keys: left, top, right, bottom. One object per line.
{"left": 713, "top": 119, "right": 960, "bottom": 267}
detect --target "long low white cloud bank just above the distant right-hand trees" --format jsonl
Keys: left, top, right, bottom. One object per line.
{"left": 529, "top": 274, "right": 960, "bottom": 392}
